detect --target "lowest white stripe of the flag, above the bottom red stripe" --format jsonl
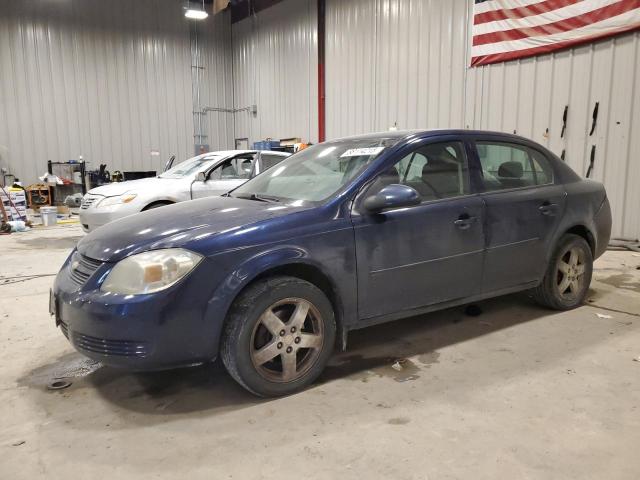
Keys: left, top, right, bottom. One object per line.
{"left": 471, "top": 9, "right": 640, "bottom": 57}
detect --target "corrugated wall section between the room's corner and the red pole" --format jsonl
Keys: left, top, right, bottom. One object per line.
{"left": 232, "top": 0, "right": 318, "bottom": 144}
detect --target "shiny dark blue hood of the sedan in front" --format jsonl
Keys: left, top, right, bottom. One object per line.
{"left": 77, "top": 197, "right": 309, "bottom": 262}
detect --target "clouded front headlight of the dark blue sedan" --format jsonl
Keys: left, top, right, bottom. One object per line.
{"left": 100, "top": 248, "right": 202, "bottom": 295}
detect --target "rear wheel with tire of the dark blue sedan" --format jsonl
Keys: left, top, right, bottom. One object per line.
{"left": 532, "top": 234, "right": 593, "bottom": 310}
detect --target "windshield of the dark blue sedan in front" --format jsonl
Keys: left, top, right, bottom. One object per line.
{"left": 231, "top": 138, "right": 398, "bottom": 203}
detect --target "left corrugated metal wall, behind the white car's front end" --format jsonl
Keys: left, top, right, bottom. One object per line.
{"left": 0, "top": 0, "right": 233, "bottom": 183}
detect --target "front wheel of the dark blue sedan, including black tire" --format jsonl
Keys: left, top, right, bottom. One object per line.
{"left": 220, "top": 276, "right": 336, "bottom": 397}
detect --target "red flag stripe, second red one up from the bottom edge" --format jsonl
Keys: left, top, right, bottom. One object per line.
{"left": 473, "top": 0, "right": 640, "bottom": 45}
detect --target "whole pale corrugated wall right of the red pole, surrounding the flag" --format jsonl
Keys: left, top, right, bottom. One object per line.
{"left": 326, "top": 0, "right": 640, "bottom": 238}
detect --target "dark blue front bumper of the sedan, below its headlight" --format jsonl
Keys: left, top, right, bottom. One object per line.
{"left": 50, "top": 253, "right": 220, "bottom": 371}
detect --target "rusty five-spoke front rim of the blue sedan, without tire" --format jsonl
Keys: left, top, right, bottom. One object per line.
{"left": 251, "top": 298, "right": 324, "bottom": 382}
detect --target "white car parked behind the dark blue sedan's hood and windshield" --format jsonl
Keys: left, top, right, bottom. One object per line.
{"left": 80, "top": 150, "right": 290, "bottom": 232}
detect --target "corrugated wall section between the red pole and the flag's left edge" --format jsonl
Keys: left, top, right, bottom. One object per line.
{"left": 326, "top": 0, "right": 467, "bottom": 138}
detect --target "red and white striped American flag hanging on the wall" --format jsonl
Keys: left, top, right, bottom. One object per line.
{"left": 471, "top": 0, "right": 640, "bottom": 66}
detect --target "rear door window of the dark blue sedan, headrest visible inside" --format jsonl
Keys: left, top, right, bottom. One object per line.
{"left": 476, "top": 142, "right": 553, "bottom": 191}
